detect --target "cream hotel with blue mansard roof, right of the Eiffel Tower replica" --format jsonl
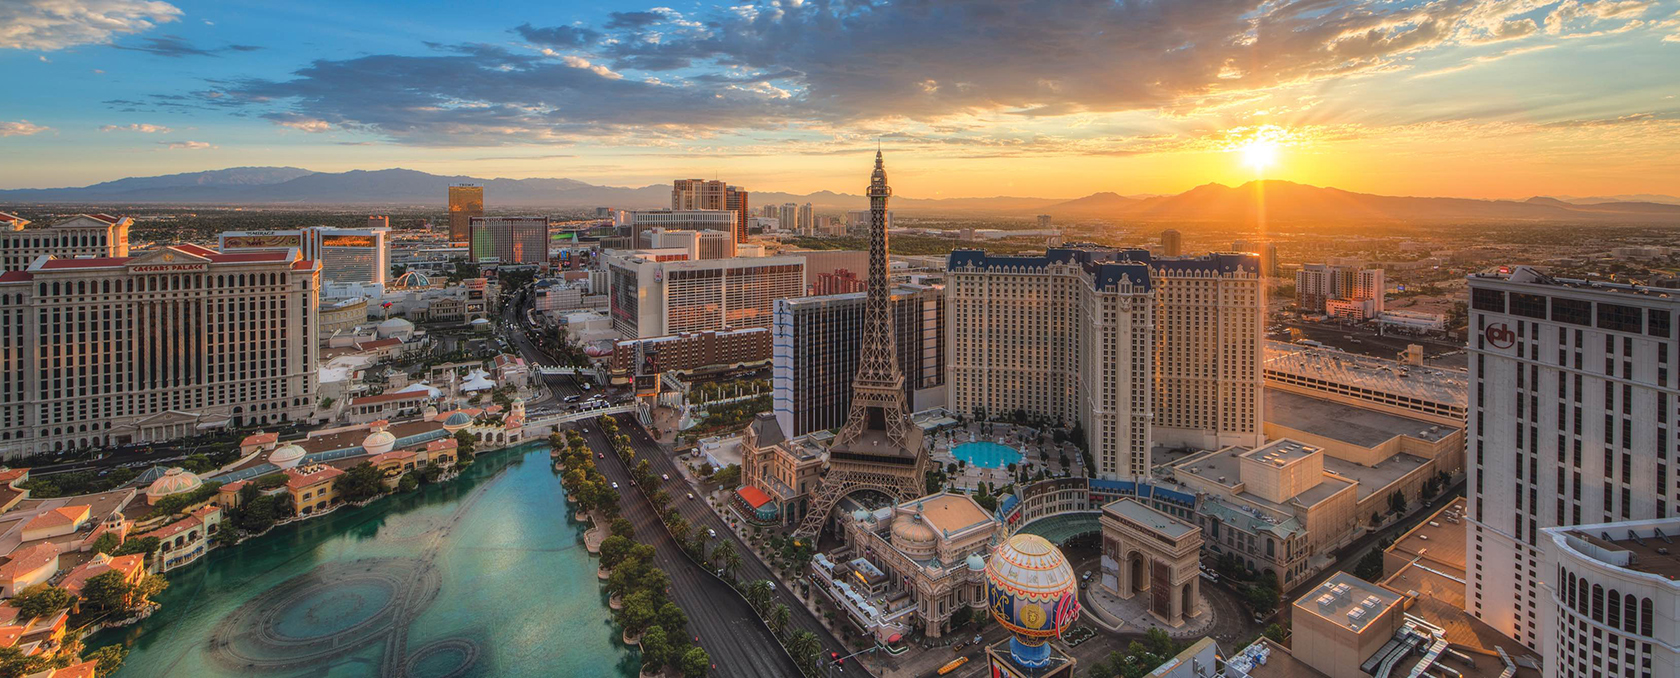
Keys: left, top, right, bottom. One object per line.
{"left": 946, "top": 247, "right": 1265, "bottom": 478}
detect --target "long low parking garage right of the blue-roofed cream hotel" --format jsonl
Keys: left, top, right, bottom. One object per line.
{"left": 1262, "top": 341, "right": 1470, "bottom": 408}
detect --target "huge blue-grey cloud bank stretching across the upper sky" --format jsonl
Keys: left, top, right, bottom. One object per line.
{"left": 167, "top": 0, "right": 1648, "bottom": 146}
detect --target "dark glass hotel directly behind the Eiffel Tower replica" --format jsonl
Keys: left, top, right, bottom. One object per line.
{"left": 769, "top": 285, "right": 946, "bottom": 436}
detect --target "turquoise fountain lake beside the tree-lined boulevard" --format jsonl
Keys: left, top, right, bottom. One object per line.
{"left": 87, "top": 443, "right": 637, "bottom": 678}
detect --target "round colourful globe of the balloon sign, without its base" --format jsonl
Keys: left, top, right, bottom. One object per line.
{"left": 986, "top": 534, "right": 1079, "bottom": 649}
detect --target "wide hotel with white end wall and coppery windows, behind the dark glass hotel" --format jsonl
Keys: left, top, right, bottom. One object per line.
{"left": 606, "top": 252, "right": 805, "bottom": 339}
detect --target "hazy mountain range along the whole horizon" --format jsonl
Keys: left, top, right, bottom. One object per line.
{"left": 0, "top": 168, "right": 1680, "bottom": 225}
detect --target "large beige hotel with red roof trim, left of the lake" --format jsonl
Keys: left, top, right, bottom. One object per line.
{"left": 0, "top": 245, "right": 319, "bottom": 456}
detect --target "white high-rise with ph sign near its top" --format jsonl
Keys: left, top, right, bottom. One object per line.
{"left": 1465, "top": 267, "right": 1680, "bottom": 653}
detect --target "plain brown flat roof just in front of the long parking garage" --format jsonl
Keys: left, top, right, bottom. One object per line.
{"left": 1265, "top": 388, "right": 1458, "bottom": 448}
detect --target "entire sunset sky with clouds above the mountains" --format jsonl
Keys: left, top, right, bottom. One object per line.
{"left": 0, "top": 0, "right": 1680, "bottom": 198}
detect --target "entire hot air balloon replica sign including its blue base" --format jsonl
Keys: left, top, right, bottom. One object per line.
{"left": 986, "top": 534, "right": 1080, "bottom": 678}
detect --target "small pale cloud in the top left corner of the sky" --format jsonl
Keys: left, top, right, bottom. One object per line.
{"left": 0, "top": 0, "right": 181, "bottom": 52}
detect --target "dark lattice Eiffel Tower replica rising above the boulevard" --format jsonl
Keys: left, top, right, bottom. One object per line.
{"left": 793, "top": 151, "right": 927, "bottom": 537}
